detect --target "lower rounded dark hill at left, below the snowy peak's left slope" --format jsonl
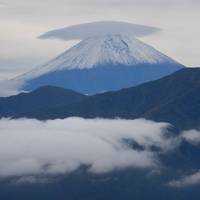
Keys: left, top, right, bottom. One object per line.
{"left": 0, "top": 86, "right": 85, "bottom": 118}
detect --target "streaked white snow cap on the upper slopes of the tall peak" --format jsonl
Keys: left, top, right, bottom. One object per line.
{"left": 21, "top": 35, "right": 175, "bottom": 78}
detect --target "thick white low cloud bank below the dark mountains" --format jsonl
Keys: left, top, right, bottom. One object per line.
{"left": 0, "top": 118, "right": 171, "bottom": 177}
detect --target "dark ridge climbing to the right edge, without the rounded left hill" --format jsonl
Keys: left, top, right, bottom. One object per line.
{"left": 0, "top": 68, "right": 200, "bottom": 129}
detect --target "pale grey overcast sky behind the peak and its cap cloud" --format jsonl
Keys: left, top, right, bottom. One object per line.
{"left": 0, "top": 0, "right": 200, "bottom": 80}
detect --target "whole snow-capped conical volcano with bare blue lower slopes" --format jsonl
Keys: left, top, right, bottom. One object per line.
{"left": 14, "top": 34, "right": 183, "bottom": 94}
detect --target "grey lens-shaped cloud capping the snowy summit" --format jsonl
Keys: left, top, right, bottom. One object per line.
{"left": 39, "top": 21, "right": 160, "bottom": 40}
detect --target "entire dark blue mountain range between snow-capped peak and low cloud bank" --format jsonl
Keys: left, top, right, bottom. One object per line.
{"left": 0, "top": 68, "right": 200, "bottom": 129}
